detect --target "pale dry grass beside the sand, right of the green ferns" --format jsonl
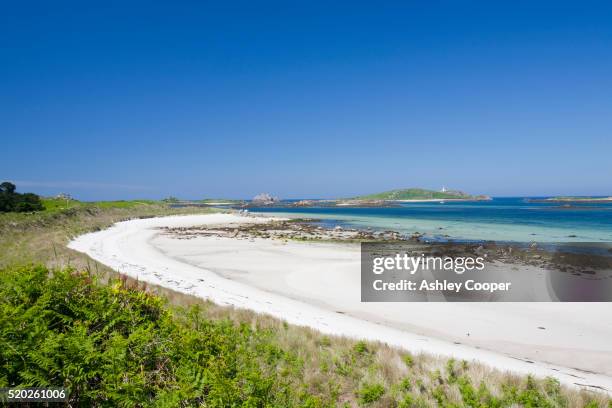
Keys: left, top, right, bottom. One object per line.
{"left": 194, "top": 302, "right": 610, "bottom": 407}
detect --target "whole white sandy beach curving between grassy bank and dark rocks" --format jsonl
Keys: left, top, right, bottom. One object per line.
{"left": 69, "top": 214, "right": 612, "bottom": 392}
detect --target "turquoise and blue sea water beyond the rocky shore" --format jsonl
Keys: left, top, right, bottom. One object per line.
{"left": 251, "top": 197, "right": 612, "bottom": 242}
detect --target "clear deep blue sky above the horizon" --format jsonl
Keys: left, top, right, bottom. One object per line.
{"left": 0, "top": 1, "right": 612, "bottom": 200}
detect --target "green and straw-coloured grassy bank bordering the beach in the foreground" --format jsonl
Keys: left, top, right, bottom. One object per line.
{"left": 0, "top": 202, "right": 610, "bottom": 407}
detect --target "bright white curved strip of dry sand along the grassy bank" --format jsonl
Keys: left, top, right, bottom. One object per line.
{"left": 69, "top": 214, "right": 612, "bottom": 393}
